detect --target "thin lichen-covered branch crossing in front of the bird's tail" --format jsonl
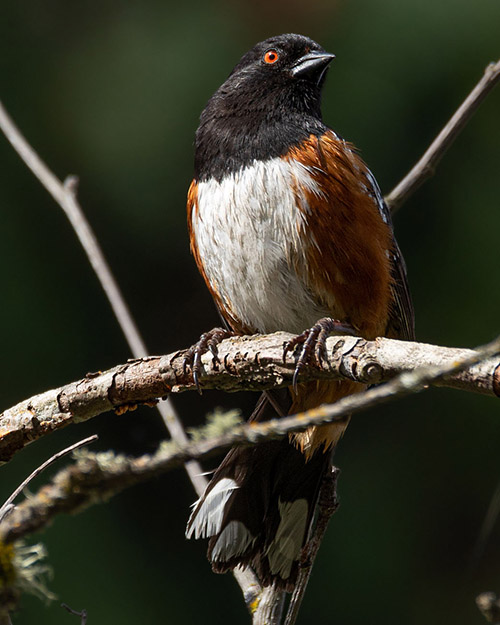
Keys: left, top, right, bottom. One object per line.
{"left": 0, "top": 337, "right": 500, "bottom": 542}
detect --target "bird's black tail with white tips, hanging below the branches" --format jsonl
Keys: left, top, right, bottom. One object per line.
{"left": 186, "top": 438, "right": 331, "bottom": 590}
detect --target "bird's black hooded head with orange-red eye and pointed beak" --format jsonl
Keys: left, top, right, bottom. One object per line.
{"left": 195, "top": 34, "right": 334, "bottom": 179}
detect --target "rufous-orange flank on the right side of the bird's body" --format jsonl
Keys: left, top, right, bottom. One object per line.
{"left": 286, "top": 131, "right": 393, "bottom": 338}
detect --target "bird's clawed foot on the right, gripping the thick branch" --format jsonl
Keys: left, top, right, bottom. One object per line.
{"left": 283, "top": 317, "right": 356, "bottom": 389}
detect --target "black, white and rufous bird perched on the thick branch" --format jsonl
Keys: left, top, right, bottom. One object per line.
{"left": 185, "top": 34, "right": 414, "bottom": 591}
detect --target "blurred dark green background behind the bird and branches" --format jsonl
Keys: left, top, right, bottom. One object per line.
{"left": 0, "top": 0, "right": 500, "bottom": 625}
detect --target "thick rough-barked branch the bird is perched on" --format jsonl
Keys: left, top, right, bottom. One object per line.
{"left": 0, "top": 332, "right": 500, "bottom": 462}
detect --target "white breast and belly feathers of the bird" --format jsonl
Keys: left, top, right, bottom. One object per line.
{"left": 192, "top": 158, "right": 328, "bottom": 333}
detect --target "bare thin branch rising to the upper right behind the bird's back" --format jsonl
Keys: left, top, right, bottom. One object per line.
{"left": 385, "top": 61, "right": 500, "bottom": 213}
